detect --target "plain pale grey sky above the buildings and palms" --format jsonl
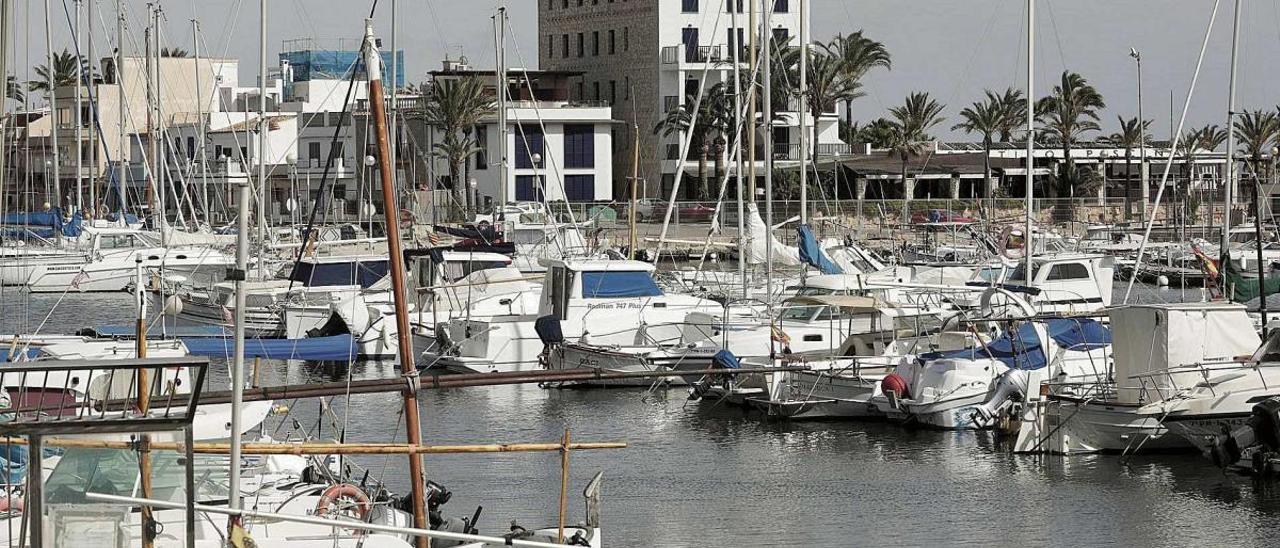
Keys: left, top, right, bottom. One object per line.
{"left": 13, "top": 0, "right": 1280, "bottom": 140}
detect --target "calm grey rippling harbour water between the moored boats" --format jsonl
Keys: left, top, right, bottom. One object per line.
{"left": 0, "top": 289, "right": 1280, "bottom": 547}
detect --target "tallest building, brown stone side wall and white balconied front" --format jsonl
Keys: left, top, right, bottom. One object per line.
{"left": 538, "top": 0, "right": 840, "bottom": 196}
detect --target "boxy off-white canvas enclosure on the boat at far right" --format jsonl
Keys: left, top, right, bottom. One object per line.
{"left": 1111, "top": 302, "right": 1262, "bottom": 403}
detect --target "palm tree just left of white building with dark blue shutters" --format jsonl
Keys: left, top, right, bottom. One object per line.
{"left": 422, "top": 77, "right": 494, "bottom": 218}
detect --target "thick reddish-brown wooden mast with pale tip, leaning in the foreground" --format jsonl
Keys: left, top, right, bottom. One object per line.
{"left": 364, "top": 19, "right": 428, "bottom": 548}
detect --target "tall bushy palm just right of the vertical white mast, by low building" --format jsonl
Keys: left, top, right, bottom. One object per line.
{"left": 1036, "top": 70, "right": 1107, "bottom": 197}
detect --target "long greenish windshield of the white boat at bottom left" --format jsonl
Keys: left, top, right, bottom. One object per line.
{"left": 45, "top": 447, "right": 228, "bottom": 504}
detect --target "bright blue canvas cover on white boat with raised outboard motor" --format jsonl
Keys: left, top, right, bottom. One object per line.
{"left": 919, "top": 318, "right": 1111, "bottom": 370}
